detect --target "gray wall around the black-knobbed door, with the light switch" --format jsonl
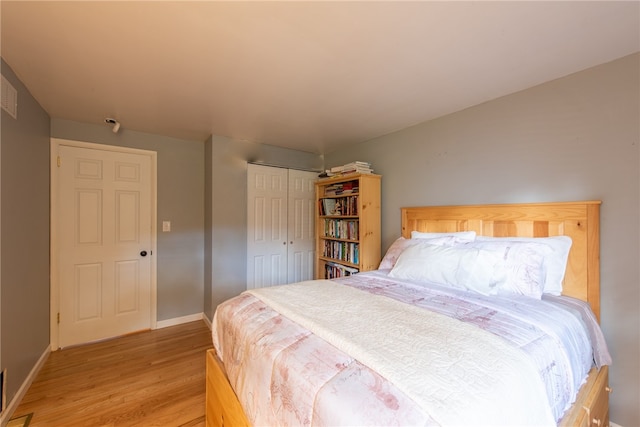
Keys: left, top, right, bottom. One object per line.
{"left": 51, "top": 119, "right": 205, "bottom": 320}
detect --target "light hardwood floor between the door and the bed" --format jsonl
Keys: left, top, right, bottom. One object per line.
{"left": 13, "top": 321, "right": 212, "bottom": 427}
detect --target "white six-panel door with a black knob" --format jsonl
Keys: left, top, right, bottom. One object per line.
{"left": 56, "top": 145, "right": 152, "bottom": 347}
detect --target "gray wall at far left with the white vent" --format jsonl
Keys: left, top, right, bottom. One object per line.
{"left": 0, "top": 60, "right": 49, "bottom": 412}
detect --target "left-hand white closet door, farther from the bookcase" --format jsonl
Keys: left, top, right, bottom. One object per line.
{"left": 247, "top": 164, "right": 288, "bottom": 289}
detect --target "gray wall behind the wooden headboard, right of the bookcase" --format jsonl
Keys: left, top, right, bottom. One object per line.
{"left": 325, "top": 54, "right": 640, "bottom": 426}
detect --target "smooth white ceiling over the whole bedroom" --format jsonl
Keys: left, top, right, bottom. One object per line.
{"left": 1, "top": 0, "right": 640, "bottom": 153}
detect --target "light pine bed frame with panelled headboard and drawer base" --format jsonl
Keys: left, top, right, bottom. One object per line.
{"left": 206, "top": 201, "right": 610, "bottom": 427}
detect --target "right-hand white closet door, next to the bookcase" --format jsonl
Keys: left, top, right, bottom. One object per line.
{"left": 287, "top": 169, "right": 318, "bottom": 283}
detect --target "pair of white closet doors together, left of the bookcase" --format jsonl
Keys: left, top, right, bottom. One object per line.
{"left": 247, "top": 164, "right": 317, "bottom": 289}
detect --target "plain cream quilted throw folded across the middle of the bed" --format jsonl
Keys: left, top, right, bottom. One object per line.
{"left": 247, "top": 280, "right": 555, "bottom": 426}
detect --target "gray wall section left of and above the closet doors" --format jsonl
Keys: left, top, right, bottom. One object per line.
{"left": 205, "top": 136, "right": 323, "bottom": 319}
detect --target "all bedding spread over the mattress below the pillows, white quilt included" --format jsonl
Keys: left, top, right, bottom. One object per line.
{"left": 212, "top": 270, "right": 611, "bottom": 426}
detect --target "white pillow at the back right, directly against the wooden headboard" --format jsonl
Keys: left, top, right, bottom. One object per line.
{"left": 475, "top": 236, "right": 572, "bottom": 295}
